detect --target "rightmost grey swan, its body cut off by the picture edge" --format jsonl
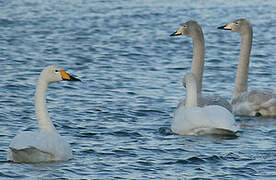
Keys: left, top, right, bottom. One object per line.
{"left": 218, "top": 19, "right": 276, "bottom": 116}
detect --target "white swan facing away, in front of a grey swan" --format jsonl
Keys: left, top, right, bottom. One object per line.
{"left": 171, "top": 72, "right": 238, "bottom": 135}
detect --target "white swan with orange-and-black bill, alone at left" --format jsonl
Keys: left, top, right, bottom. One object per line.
{"left": 7, "top": 65, "right": 80, "bottom": 163}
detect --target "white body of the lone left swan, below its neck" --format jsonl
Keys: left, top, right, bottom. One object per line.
{"left": 7, "top": 131, "right": 72, "bottom": 163}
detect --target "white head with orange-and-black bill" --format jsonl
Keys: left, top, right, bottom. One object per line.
{"left": 40, "top": 65, "right": 80, "bottom": 84}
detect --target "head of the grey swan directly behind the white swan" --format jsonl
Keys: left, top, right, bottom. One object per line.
{"left": 170, "top": 21, "right": 201, "bottom": 37}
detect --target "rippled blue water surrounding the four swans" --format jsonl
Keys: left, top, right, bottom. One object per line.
{"left": 0, "top": 0, "right": 276, "bottom": 179}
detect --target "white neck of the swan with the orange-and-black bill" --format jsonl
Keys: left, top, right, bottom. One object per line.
{"left": 35, "top": 75, "right": 56, "bottom": 132}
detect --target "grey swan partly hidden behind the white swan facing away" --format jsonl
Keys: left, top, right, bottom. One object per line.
{"left": 170, "top": 21, "right": 232, "bottom": 111}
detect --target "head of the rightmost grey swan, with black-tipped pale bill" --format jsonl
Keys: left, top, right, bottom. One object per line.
{"left": 218, "top": 19, "right": 252, "bottom": 35}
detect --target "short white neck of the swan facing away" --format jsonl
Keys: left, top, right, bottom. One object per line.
{"left": 185, "top": 78, "right": 197, "bottom": 108}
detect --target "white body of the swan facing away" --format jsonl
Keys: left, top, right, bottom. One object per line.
{"left": 172, "top": 105, "right": 237, "bottom": 135}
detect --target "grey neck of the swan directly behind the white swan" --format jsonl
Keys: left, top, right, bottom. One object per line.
{"left": 191, "top": 27, "right": 204, "bottom": 93}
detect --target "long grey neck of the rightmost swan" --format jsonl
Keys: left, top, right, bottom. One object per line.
{"left": 232, "top": 26, "right": 253, "bottom": 99}
